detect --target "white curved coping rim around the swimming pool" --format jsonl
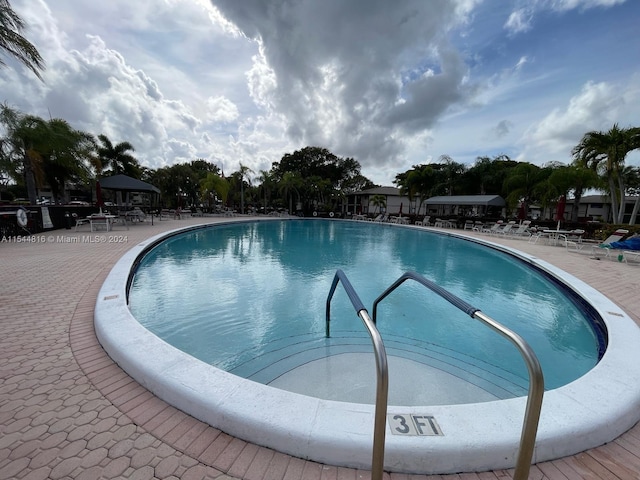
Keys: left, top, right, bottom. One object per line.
{"left": 95, "top": 219, "right": 640, "bottom": 474}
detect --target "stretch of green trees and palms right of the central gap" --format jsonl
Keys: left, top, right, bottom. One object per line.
{"left": 394, "top": 125, "right": 640, "bottom": 224}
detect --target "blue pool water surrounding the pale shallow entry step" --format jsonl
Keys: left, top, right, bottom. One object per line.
{"left": 129, "top": 220, "right": 603, "bottom": 398}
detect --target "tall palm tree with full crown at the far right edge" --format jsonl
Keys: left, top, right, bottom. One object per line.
{"left": 571, "top": 124, "right": 640, "bottom": 223}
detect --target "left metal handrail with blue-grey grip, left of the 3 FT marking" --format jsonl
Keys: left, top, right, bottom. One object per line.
{"left": 326, "top": 269, "right": 389, "bottom": 480}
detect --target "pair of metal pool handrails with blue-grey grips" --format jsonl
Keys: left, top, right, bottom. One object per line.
{"left": 326, "top": 269, "right": 544, "bottom": 480}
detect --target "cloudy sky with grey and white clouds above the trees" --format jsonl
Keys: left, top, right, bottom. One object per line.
{"left": 0, "top": 0, "right": 640, "bottom": 185}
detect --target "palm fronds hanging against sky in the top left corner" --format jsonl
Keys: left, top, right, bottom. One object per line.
{"left": 0, "top": 0, "right": 45, "bottom": 80}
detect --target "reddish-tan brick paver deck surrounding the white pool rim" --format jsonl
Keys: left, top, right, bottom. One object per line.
{"left": 0, "top": 218, "right": 640, "bottom": 480}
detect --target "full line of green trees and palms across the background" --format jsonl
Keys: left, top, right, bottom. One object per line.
{"left": 0, "top": 105, "right": 640, "bottom": 223}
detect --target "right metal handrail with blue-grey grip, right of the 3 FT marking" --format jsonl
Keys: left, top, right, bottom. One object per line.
{"left": 373, "top": 272, "right": 544, "bottom": 480}
